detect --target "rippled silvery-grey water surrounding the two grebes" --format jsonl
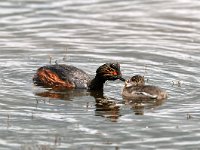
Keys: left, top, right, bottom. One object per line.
{"left": 0, "top": 0, "right": 200, "bottom": 150}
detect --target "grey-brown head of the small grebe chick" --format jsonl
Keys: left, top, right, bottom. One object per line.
{"left": 125, "top": 75, "right": 145, "bottom": 87}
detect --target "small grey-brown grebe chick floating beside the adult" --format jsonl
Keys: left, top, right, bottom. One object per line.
{"left": 122, "top": 75, "right": 167, "bottom": 100}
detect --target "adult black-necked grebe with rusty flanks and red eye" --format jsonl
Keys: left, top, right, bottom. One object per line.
{"left": 33, "top": 63, "right": 125, "bottom": 90}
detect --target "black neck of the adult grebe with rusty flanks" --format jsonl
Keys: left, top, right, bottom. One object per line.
{"left": 88, "top": 74, "right": 106, "bottom": 90}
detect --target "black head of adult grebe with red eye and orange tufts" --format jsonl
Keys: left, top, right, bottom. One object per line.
{"left": 96, "top": 63, "right": 125, "bottom": 81}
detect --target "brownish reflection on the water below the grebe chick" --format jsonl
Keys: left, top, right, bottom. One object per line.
{"left": 124, "top": 98, "right": 165, "bottom": 115}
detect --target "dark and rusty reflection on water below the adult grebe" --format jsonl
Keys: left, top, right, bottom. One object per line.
{"left": 35, "top": 89, "right": 120, "bottom": 122}
